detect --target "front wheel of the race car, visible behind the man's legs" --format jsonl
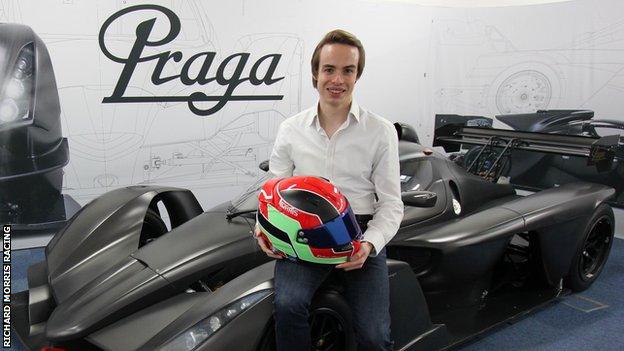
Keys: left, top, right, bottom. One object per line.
{"left": 258, "top": 293, "right": 356, "bottom": 351}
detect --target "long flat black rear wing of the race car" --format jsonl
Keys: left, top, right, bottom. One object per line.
{"left": 433, "top": 125, "right": 624, "bottom": 171}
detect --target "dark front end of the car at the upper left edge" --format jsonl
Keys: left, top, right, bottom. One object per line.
{"left": 0, "top": 23, "right": 79, "bottom": 236}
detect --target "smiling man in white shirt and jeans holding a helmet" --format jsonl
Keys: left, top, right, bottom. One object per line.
{"left": 256, "top": 30, "right": 403, "bottom": 351}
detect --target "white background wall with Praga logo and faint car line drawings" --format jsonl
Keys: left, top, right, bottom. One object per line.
{"left": 0, "top": 0, "right": 624, "bottom": 234}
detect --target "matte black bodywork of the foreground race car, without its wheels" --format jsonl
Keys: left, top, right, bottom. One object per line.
{"left": 16, "top": 126, "right": 614, "bottom": 350}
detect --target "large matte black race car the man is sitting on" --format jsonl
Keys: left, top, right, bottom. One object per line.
{"left": 12, "top": 124, "right": 614, "bottom": 351}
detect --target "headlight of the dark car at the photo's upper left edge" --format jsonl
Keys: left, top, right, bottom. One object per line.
{"left": 0, "top": 43, "right": 35, "bottom": 127}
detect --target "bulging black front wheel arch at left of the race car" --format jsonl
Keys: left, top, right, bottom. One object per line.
{"left": 45, "top": 186, "right": 202, "bottom": 302}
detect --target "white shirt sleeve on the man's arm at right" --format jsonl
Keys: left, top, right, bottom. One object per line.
{"left": 364, "top": 126, "right": 403, "bottom": 256}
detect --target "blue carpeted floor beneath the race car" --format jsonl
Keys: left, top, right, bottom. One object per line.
{"left": 6, "top": 239, "right": 624, "bottom": 351}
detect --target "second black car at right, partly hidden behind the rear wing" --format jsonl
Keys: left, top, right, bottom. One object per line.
{"left": 435, "top": 110, "right": 624, "bottom": 208}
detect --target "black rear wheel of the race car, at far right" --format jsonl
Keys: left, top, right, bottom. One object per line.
{"left": 564, "top": 204, "right": 614, "bottom": 291}
